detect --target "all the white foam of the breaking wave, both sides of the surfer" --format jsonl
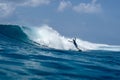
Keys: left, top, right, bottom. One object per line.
{"left": 24, "top": 25, "right": 120, "bottom": 51}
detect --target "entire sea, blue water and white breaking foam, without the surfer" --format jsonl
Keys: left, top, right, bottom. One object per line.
{"left": 0, "top": 25, "right": 120, "bottom": 80}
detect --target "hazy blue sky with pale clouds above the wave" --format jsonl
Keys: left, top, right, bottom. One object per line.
{"left": 0, "top": 0, "right": 120, "bottom": 45}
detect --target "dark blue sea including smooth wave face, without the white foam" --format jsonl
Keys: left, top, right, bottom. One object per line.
{"left": 0, "top": 25, "right": 120, "bottom": 80}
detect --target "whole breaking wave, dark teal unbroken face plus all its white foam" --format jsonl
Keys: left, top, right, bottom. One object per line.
{"left": 0, "top": 25, "right": 120, "bottom": 51}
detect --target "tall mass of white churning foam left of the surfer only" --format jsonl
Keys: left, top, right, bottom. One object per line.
{"left": 24, "top": 25, "right": 76, "bottom": 50}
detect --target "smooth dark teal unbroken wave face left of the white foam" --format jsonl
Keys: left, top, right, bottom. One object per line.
{"left": 0, "top": 25, "right": 29, "bottom": 41}
